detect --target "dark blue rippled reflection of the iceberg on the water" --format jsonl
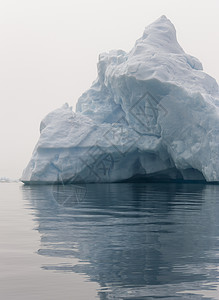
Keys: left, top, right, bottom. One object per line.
{"left": 23, "top": 184, "right": 219, "bottom": 299}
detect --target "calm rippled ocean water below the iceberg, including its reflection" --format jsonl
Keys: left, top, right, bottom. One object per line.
{"left": 0, "top": 183, "right": 219, "bottom": 300}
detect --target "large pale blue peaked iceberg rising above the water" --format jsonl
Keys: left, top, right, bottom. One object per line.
{"left": 22, "top": 16, "right": 219, "bottom": 183}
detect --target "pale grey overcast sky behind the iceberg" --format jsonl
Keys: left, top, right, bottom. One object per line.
{"left": 0, "top": 0, "right": 219, "bottom": 178}
